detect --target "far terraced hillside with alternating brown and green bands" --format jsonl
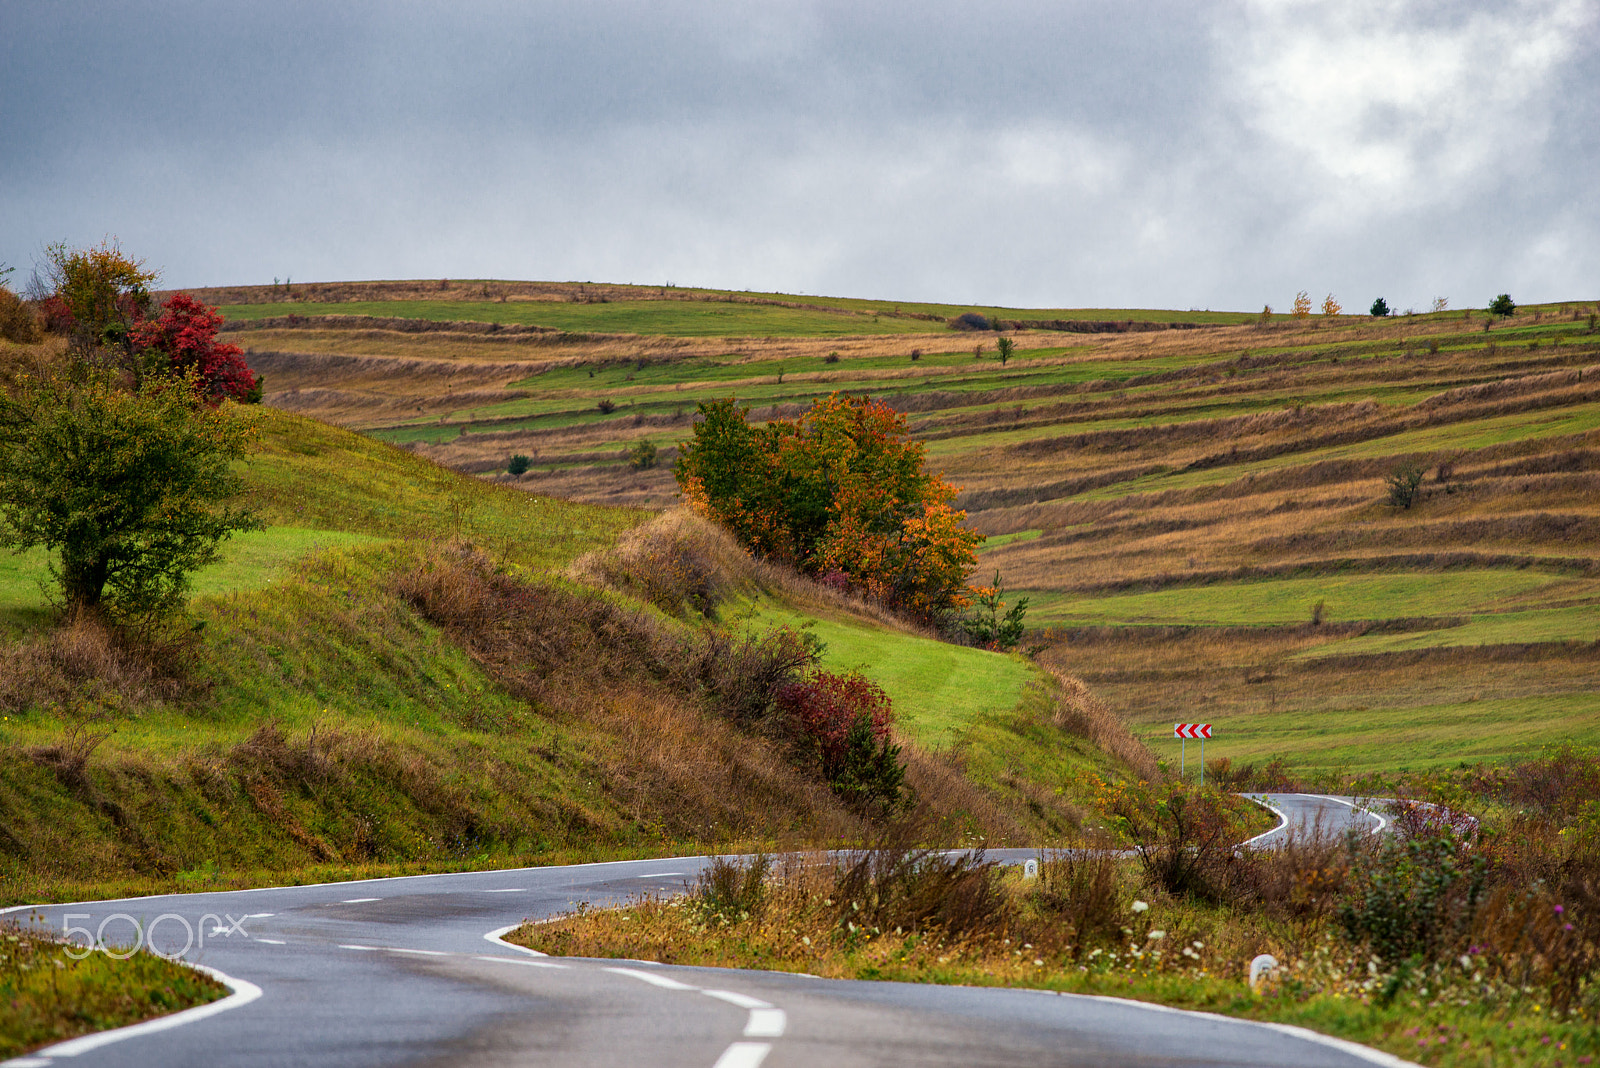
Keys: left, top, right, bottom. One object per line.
{"left": 210, "top": 283, "right": 1600, "bottom": 772}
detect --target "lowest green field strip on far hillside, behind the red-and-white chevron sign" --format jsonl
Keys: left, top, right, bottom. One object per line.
{"left": 1133, "top": 692, "right": 1600, "bottom": 775}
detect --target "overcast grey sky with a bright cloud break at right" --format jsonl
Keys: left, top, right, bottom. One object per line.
{"left": 0, "top": 0, "right": 1600, "bottom": 310}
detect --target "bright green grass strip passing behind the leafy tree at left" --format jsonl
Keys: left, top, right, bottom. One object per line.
{"left": 0, "top": 526, "right": 382, "bottom": 627}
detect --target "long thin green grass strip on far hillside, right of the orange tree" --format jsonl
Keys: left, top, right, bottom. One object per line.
{"left": 1018, "top": 569, "right": 1562, "bottom": 627}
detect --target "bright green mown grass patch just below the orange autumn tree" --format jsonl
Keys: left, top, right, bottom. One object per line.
{"left": 739, "top": 591, "right": 1038, "bottom": 750}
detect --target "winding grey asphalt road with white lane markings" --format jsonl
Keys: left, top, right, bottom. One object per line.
{"left": 0, "top": 795, "right": 1406, "bottom": 1068}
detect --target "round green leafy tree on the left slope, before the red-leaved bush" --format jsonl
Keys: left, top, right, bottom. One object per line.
{"left": 0, "top": 368, "right": 256, "bottom": 620}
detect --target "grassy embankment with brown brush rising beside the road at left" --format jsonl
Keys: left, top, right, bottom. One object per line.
{"left": 0, "top": 399, "right": 1136, "bottom": 903}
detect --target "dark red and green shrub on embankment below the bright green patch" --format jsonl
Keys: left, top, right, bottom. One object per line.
{"left": 778, "top": 671, "right": 906, "bottom": 809}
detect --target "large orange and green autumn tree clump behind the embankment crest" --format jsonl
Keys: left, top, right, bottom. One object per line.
{"left": 677, "top": 393, "right": 984, "bottom": 619}
